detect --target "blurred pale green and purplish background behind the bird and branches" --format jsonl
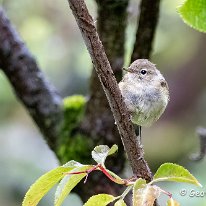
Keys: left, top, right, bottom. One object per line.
{"left": 0, "top": 0, "right": 206, "bottom": 206}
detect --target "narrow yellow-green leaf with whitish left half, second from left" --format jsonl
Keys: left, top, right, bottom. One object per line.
{"left": 54, "top": 165, "right": 93, "bottom": 206}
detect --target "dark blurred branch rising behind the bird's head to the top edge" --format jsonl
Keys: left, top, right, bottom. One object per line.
{"left": 131, "top": 0, "right": 160, "bottom": 62}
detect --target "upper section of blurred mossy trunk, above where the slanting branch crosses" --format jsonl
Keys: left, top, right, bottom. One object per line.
{"left": 96, "top": 0, "right": 129, "bottom": 78}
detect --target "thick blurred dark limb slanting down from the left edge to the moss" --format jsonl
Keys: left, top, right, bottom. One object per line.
{"left": 0, "top": 8, "right": 63, "bottom": 150}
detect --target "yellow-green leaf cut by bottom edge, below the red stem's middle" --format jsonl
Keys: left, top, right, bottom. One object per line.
{"left": 84, "top": 194, "right": 116, "bottom": 206}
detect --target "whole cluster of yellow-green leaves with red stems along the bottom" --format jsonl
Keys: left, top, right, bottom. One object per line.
{"left": 22, "top": 145, "right": 201, "bottom": 206}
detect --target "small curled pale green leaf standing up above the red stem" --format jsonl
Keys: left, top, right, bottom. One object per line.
{"left": 92, "top": 145, "right": 118, "bottom": 165}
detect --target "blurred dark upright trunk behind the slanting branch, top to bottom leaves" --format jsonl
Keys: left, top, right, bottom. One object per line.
{"left": 78, "top": 0, "right": 129, "bottom": 201}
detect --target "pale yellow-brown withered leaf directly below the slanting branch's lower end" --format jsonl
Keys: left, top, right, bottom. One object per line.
{"left": 133, "top": 178, "right": 161, "bottom": 206}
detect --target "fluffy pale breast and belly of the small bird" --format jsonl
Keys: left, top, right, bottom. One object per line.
{"left": 120, "top": 80, "right": 168, "bottom": 126}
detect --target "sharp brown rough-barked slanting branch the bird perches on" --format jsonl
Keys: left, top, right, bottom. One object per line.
{"left": 68, "top": 0, "right": 152, "bottom": 179}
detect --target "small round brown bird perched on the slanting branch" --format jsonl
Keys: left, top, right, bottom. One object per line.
{"left": 119, "top": 59, "right": 169, "bottom": 129}
